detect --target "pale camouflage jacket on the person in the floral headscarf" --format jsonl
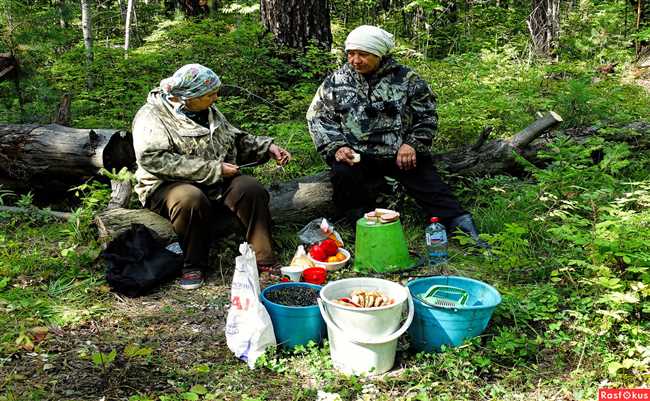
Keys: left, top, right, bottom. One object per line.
{"left": 133, "top": 89, "right": 273, "bottom": 205}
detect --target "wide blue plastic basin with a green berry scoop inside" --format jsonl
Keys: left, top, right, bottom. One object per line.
{"left": 406, "top": 276, "right": 501, "bottom": 352}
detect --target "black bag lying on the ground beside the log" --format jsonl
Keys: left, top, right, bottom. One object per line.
{"left": 101, "top": 223, "right": 183, "bottom": 297}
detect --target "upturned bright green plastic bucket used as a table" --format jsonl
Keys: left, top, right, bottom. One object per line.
{"left": 354, "top": 217, "right": 416, "bottom": 273}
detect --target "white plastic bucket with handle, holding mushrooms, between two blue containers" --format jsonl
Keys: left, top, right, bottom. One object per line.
{"left": 318, "top": 278, "right": 414, "bottom": 375}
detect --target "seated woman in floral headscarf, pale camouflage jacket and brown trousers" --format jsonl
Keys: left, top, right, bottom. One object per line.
{"left": 133, "top": 64, "right": 291, "bottom": 289}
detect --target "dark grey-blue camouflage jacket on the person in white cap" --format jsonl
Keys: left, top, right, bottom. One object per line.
{"left": 307, "top": 58, "right": 438, "bottom": 163}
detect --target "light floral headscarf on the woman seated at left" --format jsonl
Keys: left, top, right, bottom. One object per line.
{"left": 160, "top": 64, "right": 221, "bottom": 100}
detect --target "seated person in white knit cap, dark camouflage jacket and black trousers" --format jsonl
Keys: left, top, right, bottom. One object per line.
{"left": 307, "top": 25, "right": 486, "bottom": 246}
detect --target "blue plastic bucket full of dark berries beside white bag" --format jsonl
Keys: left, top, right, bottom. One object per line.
{"left": 260, "top": 282, "right": 327, "bottom": 348}
